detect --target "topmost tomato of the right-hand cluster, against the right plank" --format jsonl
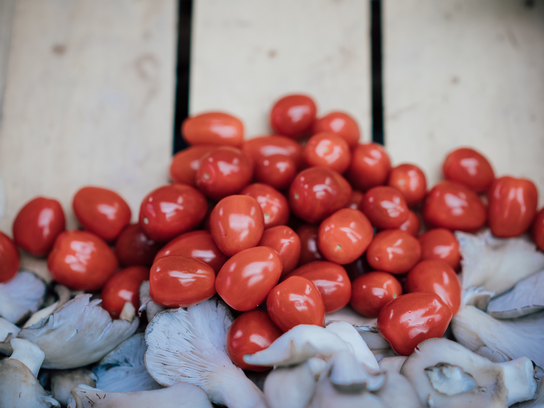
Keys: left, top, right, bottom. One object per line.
{"left": 442, "top": 148, "right": 495, "bottom": 193}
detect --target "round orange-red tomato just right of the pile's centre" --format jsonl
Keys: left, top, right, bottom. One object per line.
{"left": 317, "top": 208, "right": 374, "bottom": 265}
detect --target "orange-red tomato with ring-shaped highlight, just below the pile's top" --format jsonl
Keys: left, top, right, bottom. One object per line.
{"left": 302, "top": 132, "right": 351, "bottom": 173}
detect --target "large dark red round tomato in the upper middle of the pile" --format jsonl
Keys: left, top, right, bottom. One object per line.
{"left": 289, "top": 167, "right": 351, "bottom": 223}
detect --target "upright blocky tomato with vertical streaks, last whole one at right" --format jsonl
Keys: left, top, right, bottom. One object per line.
{"left": 487, "top": 176, "right": 538, "bottom": 238}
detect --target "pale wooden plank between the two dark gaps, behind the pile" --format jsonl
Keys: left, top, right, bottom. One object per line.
{"left": 189, "top": 0, "right": 370, "bottom": 141}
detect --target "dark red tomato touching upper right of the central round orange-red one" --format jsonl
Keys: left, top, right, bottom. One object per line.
{"left": 360, "top": 186, "right": 409, "bottom": 229}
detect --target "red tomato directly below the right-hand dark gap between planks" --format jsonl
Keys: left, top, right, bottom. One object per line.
{"left": 347, "top": 143, "right": 391, "bottom": 192}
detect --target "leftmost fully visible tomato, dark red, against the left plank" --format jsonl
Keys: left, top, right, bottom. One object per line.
{"left": 13, "top": 197, "right": 66, "bottom": 256}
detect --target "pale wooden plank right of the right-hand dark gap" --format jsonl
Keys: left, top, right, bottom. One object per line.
{"left": 383, "top": 0, "right": 544, "bottom": 205}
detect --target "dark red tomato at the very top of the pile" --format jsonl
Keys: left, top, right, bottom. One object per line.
{"left": 270, "top": 95, "right": 317, "bottom": 139}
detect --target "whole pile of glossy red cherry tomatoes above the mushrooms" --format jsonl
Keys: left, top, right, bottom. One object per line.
{"left": 0, "top": 95, "right": 544, "bottom": 364}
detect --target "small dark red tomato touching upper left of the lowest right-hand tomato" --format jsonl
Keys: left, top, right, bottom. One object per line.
{"left": 349, "top": 272, "right": 402, "bottom": 317}
